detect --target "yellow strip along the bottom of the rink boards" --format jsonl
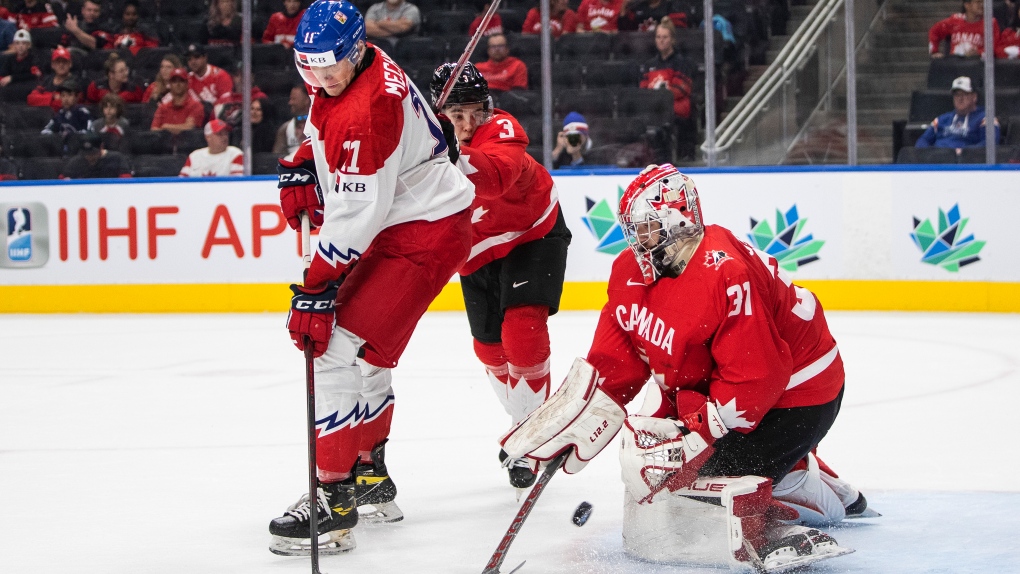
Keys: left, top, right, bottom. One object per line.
{"left": 0, "top": 280, "right": 1020, "bottom": 313}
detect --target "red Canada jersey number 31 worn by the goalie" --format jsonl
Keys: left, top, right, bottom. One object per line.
{"left": 588, "top": 225, "right": 844, "bottom": 432}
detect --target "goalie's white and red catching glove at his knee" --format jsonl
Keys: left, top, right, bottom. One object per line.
{"left": 620, "top": 390, "right": 728, "bottom": 503}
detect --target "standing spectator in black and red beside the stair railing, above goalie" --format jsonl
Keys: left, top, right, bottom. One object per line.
{"left": 641, "top": 16, "right": 698, "bottom": 158}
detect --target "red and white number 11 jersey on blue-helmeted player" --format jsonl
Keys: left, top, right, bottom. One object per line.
{"left": 305, "top": 44, "right": 474, "bottom": 289}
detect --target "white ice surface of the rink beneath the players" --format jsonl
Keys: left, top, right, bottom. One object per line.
{"left": 0, "top": 312, "right": 1020, "bottom": 574}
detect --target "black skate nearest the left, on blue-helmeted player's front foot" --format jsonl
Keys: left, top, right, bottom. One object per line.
{"left": 269, "top": 478, "right": 358, "bottom": 556}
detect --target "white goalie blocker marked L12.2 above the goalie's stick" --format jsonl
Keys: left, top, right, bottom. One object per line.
{"left": 500, "top": 357, "right": 627, "bottom": 474}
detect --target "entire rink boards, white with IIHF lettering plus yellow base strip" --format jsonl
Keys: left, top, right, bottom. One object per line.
{"left": 0, "top": 168, "right": 1020, "bottom": 313}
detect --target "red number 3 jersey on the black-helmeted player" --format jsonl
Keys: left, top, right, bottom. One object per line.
{"left": 457, "top": 109, "right": 559, "bottom": 275}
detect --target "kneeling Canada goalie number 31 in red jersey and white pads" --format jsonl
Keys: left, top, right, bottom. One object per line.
{"left": 501, "top": 164, "right": 878, "bottom": 572}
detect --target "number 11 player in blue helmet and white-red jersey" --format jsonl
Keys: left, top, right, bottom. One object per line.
{"left": 269, "top": 0, "right": 474, "bottom": 555}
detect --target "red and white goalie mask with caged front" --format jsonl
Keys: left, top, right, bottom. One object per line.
{"left": 618, "top": 163, "right": 705, "bottom": 284}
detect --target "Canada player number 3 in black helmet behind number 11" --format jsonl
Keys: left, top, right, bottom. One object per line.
{"left": 429, "top": 62, "right": 570, "bottom": 488}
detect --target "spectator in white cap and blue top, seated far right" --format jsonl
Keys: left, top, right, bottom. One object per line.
{"left": 914, "top": 75, "right": 1000, "bottom": 149}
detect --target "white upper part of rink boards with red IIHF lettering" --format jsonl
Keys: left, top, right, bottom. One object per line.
{"left": 0, "top": 169, "right": 1020, "bottom": 285}
